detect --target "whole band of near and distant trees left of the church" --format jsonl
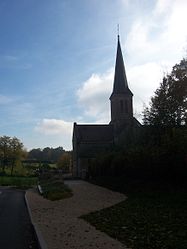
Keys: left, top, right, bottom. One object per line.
{"left": 0, "top": 136, "right": 71, "bottom": 175}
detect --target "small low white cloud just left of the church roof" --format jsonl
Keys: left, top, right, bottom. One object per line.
{"left": 35, "top": 118, "right": 72, "bottom": 136}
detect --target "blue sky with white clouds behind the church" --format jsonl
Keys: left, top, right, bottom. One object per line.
{"left": 0, "top": 0, "right": 187, "bottom": 150}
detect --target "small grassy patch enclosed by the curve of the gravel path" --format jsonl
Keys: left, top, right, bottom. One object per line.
{"left": 40, "top": 179, "right": 73, "bottom": 201}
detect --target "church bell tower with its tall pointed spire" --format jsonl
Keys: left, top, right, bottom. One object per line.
{"left": 110, "top": 35, "right": 133, "bottom": 134}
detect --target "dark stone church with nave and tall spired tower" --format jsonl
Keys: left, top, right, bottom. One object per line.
{"left": 73, "top": 35, "right": 141, "bottom": 178}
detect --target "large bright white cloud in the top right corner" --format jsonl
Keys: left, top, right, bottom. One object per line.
{"left": 126, "top": 0, "right": 187, "bottom": 64}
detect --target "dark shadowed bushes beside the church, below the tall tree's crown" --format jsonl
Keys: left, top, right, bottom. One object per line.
{"left": 89, "top": 127, "right": 187, "bottom": 181}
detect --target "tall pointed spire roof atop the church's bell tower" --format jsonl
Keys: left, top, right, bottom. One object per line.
{"left": 111, "top": 35, "right": 133, "bottom": 97}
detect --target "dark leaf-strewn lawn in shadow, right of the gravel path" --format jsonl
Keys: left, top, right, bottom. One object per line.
{"left": 82, "top": 179, "right": 187, "bottom": 249}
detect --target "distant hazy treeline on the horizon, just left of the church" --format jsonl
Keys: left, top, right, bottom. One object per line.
{"left": 27, "top": 147, "right": 65, "bottom": 163}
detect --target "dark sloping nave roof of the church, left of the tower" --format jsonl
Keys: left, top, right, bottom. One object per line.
{"left": 74, "top": 123, "right": 113, "bottom": 143}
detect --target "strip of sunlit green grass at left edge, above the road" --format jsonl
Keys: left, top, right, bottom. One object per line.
{"left": 0, "top": 176, "right": 37, "bottom": 189}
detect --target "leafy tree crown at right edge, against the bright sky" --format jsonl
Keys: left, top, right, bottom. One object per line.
{"left": 143, "top": 59, "right": 187, "bottom": 127}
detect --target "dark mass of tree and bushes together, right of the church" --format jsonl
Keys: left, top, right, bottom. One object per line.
{"left": 89, "top": 59, "right": 187, "bottom": 182}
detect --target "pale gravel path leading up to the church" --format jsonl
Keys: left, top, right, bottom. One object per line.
{"left": 26, "top": 180, "right": 126, "bottom": 249}
